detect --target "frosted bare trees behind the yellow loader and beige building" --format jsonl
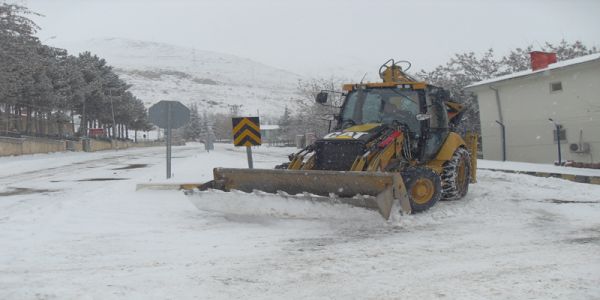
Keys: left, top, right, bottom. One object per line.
{"left": 279, "top": 40, "right": 598, "bottom": 139}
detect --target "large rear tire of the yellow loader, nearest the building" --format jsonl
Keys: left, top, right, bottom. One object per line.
{"left": 442, "top": 148, "right": 471, "bottom": 200}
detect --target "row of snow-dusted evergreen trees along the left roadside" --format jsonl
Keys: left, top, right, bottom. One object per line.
{"left": 0, "top": 3, "right": 151, "bottom": 138}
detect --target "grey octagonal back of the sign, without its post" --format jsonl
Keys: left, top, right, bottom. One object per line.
{"left": 148, "top": 100, "right": 190, "bottom": 128}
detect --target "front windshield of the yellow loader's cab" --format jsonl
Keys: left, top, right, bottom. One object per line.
{"left": 341, "top": 89, "right": 420, "bottom": 132}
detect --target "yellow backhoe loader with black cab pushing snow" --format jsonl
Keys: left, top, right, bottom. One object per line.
{"left": 142, "top": 59, "right": 477, "bottom": 219}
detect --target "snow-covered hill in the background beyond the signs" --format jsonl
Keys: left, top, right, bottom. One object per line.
{"left": 66, "top": 38, "right": 301, "bottom": 116}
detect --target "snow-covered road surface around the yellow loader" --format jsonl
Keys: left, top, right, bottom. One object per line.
{"left": 0, "top": 144, "right": 600, "bottom": 299}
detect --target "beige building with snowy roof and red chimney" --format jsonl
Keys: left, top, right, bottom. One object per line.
{"left": 466, "top": 52, "right": 600, "bottom": 163}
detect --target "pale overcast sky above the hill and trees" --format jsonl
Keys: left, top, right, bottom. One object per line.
{"left": 22, "top": 0, "right": 600, "bottom": 76}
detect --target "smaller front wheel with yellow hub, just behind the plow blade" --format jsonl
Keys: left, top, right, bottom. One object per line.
{"left": 402, "top": 167, "right": 442, "bottom": 212}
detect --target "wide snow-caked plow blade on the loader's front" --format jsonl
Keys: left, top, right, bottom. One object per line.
{"left": 199, "top": 168, "right": 411, "bottom": 220}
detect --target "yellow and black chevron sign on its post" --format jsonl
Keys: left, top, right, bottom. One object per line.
{"left": 231, "top": 117, "right": 261, "bottom": 169}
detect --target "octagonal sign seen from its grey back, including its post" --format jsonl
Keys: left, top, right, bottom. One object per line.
{"left": 148, "top": 100, "right": 190, "bottom": 179}
